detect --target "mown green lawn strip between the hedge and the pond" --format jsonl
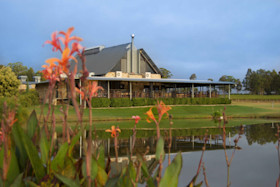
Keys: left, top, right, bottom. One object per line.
{"left": 26, "top": 102, "right": 280, "bottom": 129}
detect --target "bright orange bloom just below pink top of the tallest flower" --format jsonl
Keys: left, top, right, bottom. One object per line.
{"left": 46, "top": 48, "right": 78, "bottom": 73}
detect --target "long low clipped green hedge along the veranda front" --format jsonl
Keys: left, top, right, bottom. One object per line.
{"left": 88, "top": 98, "right": 231, "bottom": 108}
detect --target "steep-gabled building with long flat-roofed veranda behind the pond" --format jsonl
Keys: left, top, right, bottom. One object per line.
{"left": 33, "top": 36, "right": 234, "bottom": 103}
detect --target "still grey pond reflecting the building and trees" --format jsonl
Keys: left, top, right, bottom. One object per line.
{"left": 92, "top": 123, "right": 279, "bottom": 186}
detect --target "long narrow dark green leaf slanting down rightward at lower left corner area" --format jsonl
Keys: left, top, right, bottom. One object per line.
{"left": 14, "top": 125, "right": 46, "bottom": 181}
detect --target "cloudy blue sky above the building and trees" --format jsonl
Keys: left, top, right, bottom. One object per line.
{"left": 0, "top": 0, "right": 280, "bottom": 80}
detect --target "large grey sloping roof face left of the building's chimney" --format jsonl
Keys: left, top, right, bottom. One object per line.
{"left": 78, "top": 43, "right": 130, "bottom": 75}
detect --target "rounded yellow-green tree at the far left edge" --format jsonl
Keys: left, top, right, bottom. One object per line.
{"left": 0, "top": 66, "right": 20, "bottom": 97}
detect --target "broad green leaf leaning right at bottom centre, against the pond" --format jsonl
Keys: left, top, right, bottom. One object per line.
{"left": 159, "top": 152, "right": 182, "bottom": 187}
